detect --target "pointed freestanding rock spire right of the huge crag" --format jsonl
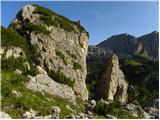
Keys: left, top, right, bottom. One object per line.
{"left": 96, "top": 54, "right": 128, "bottom": 103}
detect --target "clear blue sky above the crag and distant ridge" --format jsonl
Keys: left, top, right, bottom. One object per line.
{"left": 1, "top": 1, "right": 159, "bottom": 45}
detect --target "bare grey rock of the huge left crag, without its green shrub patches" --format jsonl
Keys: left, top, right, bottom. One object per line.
{"left": 13, "top": 5, "right": 88, "bottom": 100}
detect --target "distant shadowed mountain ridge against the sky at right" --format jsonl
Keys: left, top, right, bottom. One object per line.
{"left": 96, "top": 31, "right": 159, "bottom": 60}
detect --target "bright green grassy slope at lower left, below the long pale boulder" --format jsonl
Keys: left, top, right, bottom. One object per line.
{"left": 1, "top": 72, "right": 77, "bottom": 118}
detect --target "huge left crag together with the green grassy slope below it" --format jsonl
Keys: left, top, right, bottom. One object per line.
{"left": 0, "top": 4, "right": 89, "bottom": 118}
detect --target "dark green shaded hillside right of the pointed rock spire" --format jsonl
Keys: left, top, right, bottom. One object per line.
{"left": 120, "top": 55, "right": 159, "bottom": 107}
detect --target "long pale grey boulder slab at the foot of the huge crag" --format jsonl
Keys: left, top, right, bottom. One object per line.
{"left": 26, "top": 74, "right": 75, "bottom": 102}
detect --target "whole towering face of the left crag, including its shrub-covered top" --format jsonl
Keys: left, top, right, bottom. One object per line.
{"left": 10, "top": 5, "right": 88, "bottom": 100}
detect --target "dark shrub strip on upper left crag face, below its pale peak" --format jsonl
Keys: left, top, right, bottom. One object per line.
{"left": 25, "top": 23, "right": 50, "bottom": 35}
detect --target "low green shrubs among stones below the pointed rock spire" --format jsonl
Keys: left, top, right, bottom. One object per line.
{"left": 94, "top": 101, "right": 140, "bottom": 119}
